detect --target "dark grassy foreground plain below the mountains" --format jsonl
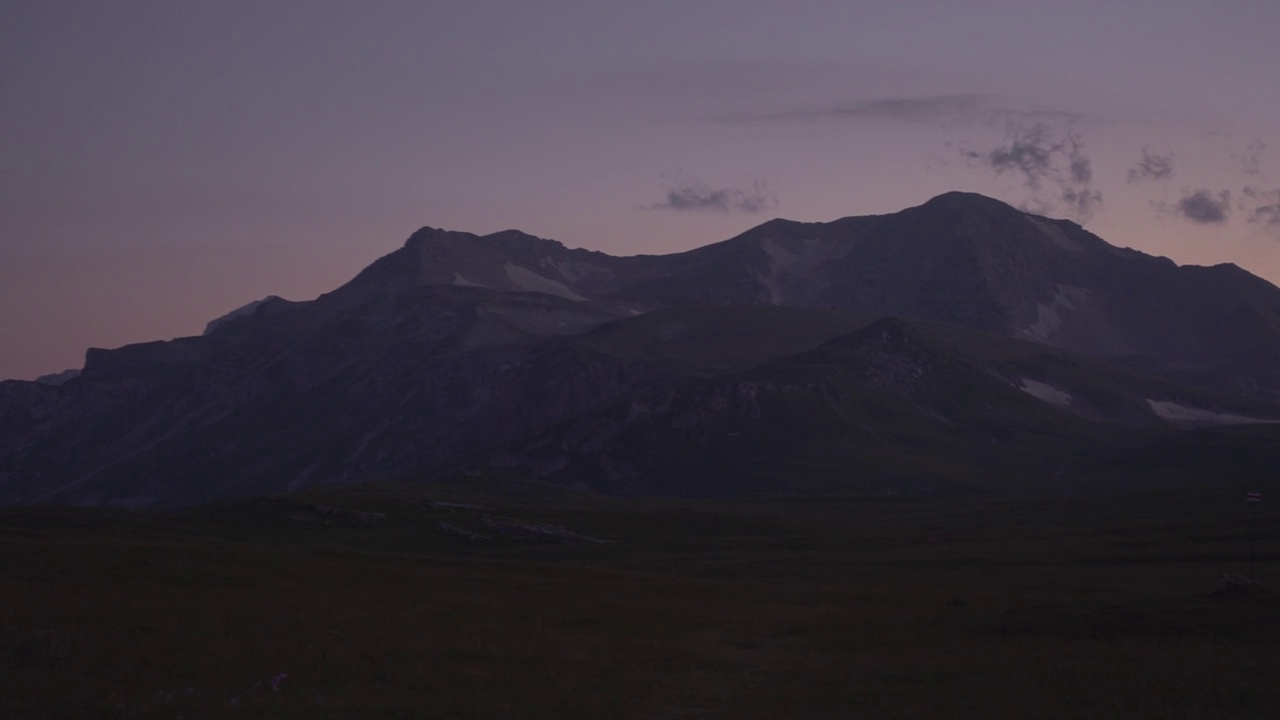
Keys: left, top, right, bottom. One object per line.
{"left": 0, "top": 476, "right": 1280, "bottom": 719}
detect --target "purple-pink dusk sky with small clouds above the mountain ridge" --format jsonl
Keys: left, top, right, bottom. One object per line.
{"left": 0, "top": 0, "right": 1280, "bottom": 379}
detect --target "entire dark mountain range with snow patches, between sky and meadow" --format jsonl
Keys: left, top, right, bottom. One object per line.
{"left": 0, "top": 193, "right": 1280, "bottom": 506}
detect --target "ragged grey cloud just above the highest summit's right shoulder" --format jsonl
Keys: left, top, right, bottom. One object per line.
{"left": 960, "top": 120, "right": 1102, "bottom": 222}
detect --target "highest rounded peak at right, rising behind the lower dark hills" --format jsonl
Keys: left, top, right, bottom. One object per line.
{"left": 606, "top": 192, "right": 1280, "bottom": 398}
